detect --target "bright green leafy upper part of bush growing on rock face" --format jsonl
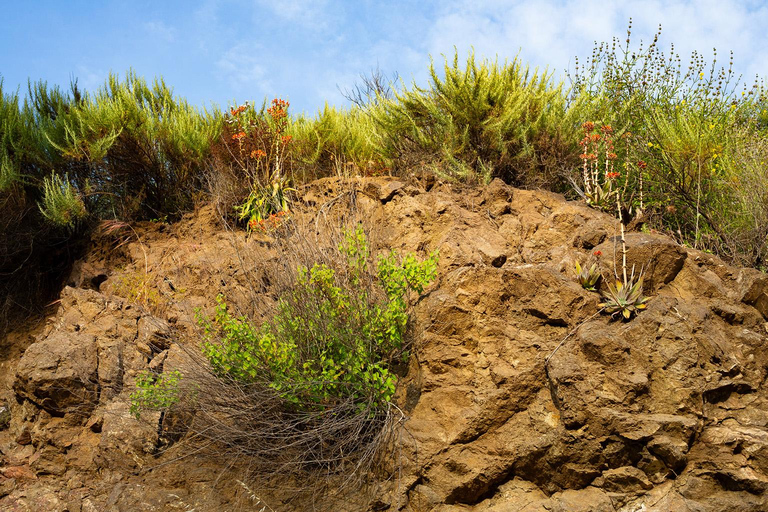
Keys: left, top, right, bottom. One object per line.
{"left": 201, "top": 228, "right": 437, "bottom": 411}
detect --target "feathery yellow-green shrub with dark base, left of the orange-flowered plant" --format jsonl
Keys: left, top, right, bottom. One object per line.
{"left": 45, "top": 72, "right": 220, "bottom": 217}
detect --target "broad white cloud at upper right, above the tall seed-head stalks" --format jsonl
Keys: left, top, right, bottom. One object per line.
{"left": 425, "top": 0, "right": 768, "bottom": 83}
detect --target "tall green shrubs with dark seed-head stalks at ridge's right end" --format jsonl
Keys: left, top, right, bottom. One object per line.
{"left": 569, "top": 23, "right": 768, "bottom": 266}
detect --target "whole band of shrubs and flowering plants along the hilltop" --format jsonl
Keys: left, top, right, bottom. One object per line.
{"left": 0, "top": 26, "right": 768, "bottom": 326}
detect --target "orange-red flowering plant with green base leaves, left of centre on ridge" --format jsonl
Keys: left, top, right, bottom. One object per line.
{"left": 224, "top": 98, "right": 294, "bottom": 232}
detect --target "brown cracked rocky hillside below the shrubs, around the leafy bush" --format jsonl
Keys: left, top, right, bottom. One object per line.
{"left": 0, "top": 178, "right": 768, "bottom": 512}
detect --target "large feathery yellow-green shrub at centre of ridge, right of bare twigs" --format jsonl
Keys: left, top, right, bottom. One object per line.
{"left": 372, "top": 50, "right": 571, "bottom": 183}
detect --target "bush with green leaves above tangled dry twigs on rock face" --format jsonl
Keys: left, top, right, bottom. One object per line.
{"left": 184, "top": 222, "right": 437, "bottom": 478}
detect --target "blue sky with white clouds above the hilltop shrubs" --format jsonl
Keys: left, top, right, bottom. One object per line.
{"left": 0, "top": 0, "right": 768, "bottom": 113}
